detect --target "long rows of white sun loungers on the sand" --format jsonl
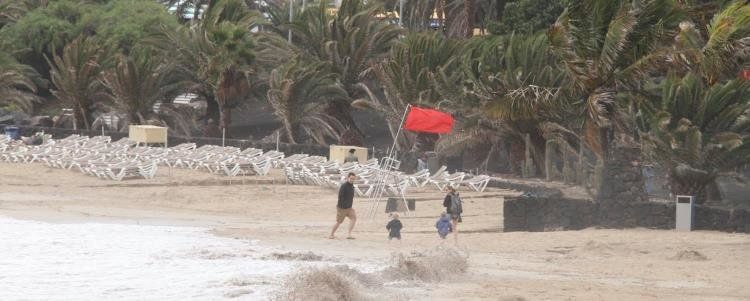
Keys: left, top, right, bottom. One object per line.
{"left": 0, "top": 131, "right": 500, "bottom": 188}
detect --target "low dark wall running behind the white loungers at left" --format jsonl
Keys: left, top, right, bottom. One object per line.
{"left": 0, "top": 126, "right": 328, "bottom": 157}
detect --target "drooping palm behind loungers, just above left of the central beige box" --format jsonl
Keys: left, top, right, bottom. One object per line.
{"left": 268, "top": 57, "right": 347, "bottom": 145}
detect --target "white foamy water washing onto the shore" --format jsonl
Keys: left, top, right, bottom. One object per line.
{"left": 0, "top": 217, "right": 294, "bottom": 300}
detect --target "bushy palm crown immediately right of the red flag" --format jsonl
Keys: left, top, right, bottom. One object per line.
{"left": 464, "top": 35, "right": 566, "bottom": 122}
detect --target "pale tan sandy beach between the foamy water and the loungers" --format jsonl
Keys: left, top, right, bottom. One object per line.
{"left": 0, "top": 163, "right": 750, "bottom": 300}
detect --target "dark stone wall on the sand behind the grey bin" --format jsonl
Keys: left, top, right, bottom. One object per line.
{"left": 503, "top": 195, "right": 750, "bottom": 233}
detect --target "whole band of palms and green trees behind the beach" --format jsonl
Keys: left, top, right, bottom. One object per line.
{"left": 0, "top": 0, "right": 750, "bottom": 200}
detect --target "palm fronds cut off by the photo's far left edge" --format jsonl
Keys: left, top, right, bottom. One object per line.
{"left": 0, "top": 52, "right": 39, "bottom": 113}
